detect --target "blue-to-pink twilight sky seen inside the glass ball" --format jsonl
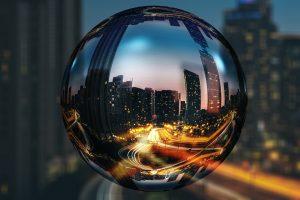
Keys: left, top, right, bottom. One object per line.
{"left": 110, "top": 20, "right": 238, "bottom": 109}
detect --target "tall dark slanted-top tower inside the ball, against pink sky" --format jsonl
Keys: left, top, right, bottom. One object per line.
{"left": 184, "top": 69, "right": 201, "bottom": 124}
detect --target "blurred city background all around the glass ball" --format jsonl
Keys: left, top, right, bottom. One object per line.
{"left": 0, "top": 0, "right": 300, "bottom": 200}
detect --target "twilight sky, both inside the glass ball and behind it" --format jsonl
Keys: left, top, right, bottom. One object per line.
{"left": 82, "top": 0, "right": 300, "bottom": 108}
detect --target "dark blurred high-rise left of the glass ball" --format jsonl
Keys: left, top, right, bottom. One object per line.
{"left": 0, "top": 0, "right": 81, "bottom": 199}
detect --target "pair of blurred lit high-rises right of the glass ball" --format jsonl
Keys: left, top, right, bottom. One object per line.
{"left": 223, "top": 0, "right": 300, "bottom": 175}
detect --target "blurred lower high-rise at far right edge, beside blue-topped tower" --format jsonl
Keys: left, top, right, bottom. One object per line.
{"left": 270, "top": 34, "right": 300, "bottom": 177}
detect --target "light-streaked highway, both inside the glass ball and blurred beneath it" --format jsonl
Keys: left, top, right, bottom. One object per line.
{"left": 80, "top": 109, "right": 300, "bottom": 200}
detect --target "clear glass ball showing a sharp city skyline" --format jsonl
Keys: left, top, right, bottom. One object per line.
{"left": 61, "top": 6, "right": 247, "bottom": 191}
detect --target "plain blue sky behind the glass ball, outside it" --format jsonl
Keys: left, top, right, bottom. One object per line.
{"left": 82, "top": 0, "right": 300, "bottom": 34}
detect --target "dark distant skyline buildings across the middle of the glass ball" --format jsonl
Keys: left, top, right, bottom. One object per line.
{"left": 65, "top": 70, "right": 240, "bottom": 135}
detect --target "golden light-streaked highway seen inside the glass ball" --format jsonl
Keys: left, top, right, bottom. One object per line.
{"left": 118, "top": 111, "right": 234, "bottom": 176}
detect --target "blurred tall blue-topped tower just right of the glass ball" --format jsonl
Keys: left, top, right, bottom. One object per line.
{"left": 223, "top": 0, "right": 279, "bottom": 160}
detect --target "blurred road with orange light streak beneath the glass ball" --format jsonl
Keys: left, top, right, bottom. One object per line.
{"left": 79, "top": 163, "right": 300, "bottom": 200}
